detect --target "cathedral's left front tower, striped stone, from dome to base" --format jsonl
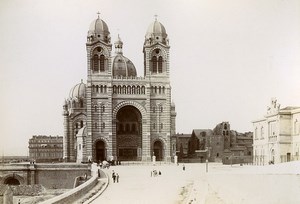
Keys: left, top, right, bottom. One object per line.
{"left": 86, "top": 14, "right": 112, "bottom": 159}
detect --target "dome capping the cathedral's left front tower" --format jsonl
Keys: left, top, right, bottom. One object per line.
{"left": 88, "top": 16, "right": 110, "bottom": 43}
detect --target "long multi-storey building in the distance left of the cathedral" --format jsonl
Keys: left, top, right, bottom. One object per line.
{"left": 28, "top": 135, "right": 63, "bottom": 162}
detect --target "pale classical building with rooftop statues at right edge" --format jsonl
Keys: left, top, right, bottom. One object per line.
{"left": 252, "top": 98, "right": 300, "bottom": 165}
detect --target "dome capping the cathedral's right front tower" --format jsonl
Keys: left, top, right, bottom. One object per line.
{"left": 145, "top": 19, "right": 168, "bottom": 45}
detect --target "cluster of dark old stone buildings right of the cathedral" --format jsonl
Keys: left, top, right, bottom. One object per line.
{"left": 188, "top": 122, "right": 253, "bottom": 163}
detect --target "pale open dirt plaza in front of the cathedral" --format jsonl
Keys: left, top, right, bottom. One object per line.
{"left": 92, "top": 162, "right": 300, "bottom": 204}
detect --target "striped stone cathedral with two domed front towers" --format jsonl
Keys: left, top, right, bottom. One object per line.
{"left": 63, "top": 15, "right": 176, "bottom": 163}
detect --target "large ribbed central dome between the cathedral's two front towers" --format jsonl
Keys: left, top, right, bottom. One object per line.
{"left": 112, "top": 54, "right": 136, "bottom": 77}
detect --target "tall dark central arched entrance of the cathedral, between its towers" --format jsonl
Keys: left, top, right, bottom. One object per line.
{"left": 116, "top": 105, "right": 142, "bottom": 161}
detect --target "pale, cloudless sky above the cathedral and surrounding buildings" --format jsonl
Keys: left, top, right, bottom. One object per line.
{"left": 0, "top": 0, "right": 300, "bottom": 155}
